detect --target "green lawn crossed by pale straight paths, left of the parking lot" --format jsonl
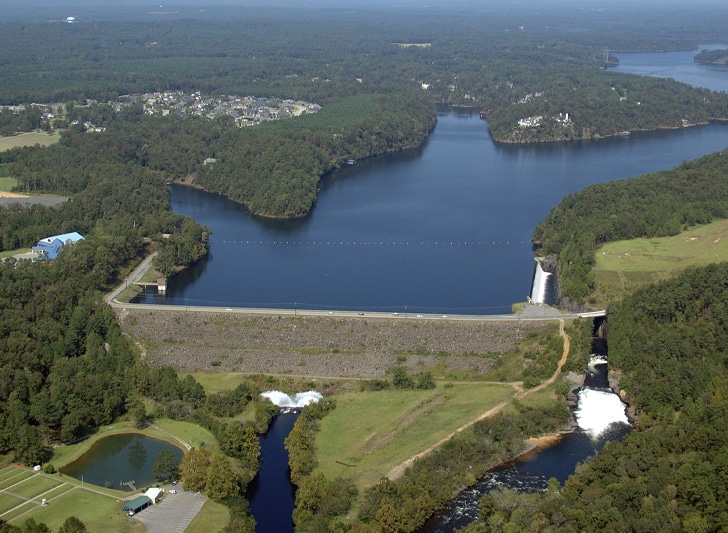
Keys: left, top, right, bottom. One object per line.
{"left": 0, "top": 466, "right": 144, "bottom": 533}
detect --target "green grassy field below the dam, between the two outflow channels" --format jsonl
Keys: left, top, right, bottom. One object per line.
{"left": 316, "top": 383, "right": 515, "bottom": 487}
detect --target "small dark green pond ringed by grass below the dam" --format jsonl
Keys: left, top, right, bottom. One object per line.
{"left": 61, "top": 433, "right": 182, "bottom": 490}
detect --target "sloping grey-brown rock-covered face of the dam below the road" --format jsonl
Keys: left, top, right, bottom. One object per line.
{"left": 118, "top": 309, "right": 548, "bottom": 379}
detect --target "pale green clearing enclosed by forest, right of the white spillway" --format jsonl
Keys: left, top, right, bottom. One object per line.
{"left": 594, "top": 220, "right": 728, "bottom": 303}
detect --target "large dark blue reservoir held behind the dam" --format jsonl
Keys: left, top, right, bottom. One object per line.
{"left": 135, "top": 113, "right": 728, "bottom": 314}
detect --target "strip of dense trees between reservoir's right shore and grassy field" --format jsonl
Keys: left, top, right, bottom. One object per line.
{"left": 533, "top": 151, "right": 728, "bottom": 303}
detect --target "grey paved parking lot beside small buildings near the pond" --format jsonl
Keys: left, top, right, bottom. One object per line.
{"left": 134, "top": 485, "right": 207, "bottom": 533}
